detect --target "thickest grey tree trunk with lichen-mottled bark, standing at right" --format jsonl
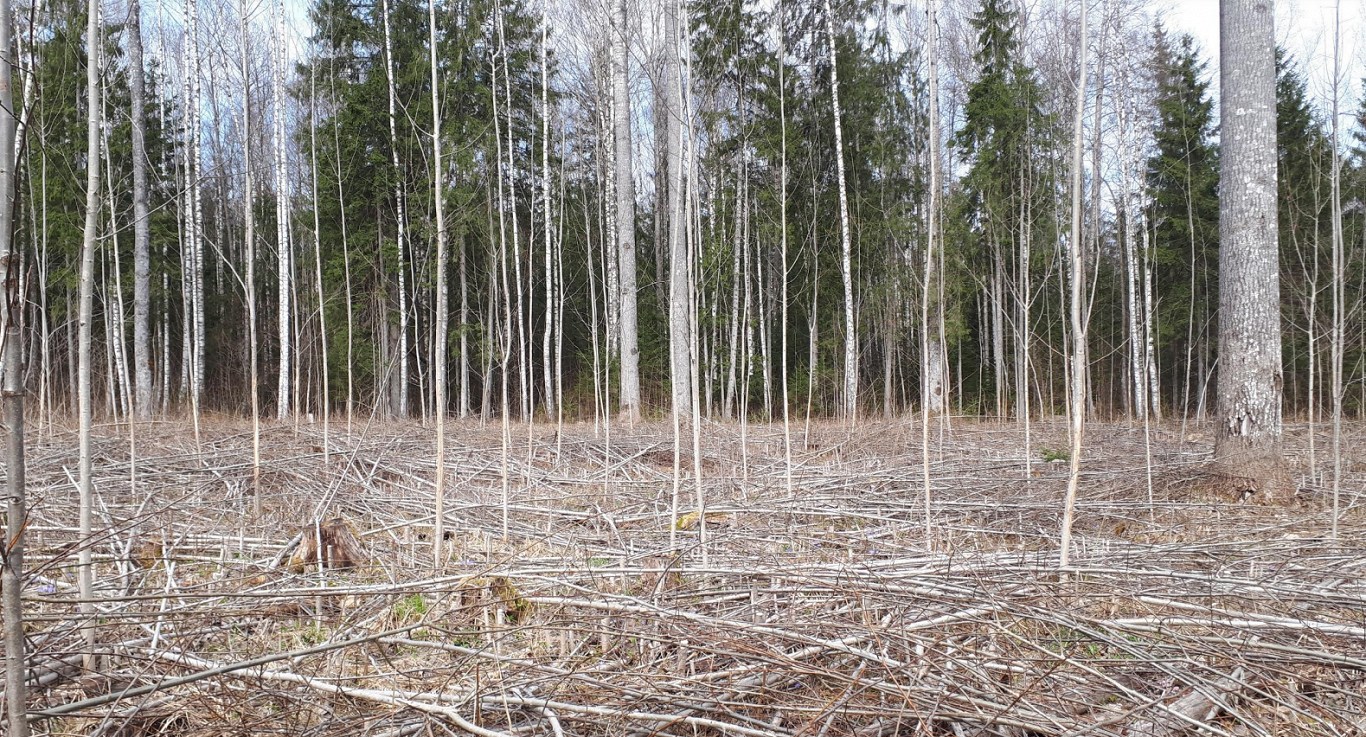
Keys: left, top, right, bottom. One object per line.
{"left": 1214, "top": 0, "right": 1291, "bottom": 498}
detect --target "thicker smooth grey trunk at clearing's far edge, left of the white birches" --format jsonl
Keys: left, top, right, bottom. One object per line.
{"left": 127, "top": 0, "right": 152, "bottom": 419}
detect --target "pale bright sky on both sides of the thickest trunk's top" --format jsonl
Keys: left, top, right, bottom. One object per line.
{"left": 1160, "top": 0, "right": 1366, "bottom": 126}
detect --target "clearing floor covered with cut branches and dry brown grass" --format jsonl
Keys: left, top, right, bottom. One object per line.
{"left": 2, "top": 416, "right": 1366, "bottom": 737}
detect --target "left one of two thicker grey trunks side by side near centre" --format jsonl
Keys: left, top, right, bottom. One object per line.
{"left": 609, "top": 0, "right": 641, "bottom": 423}
